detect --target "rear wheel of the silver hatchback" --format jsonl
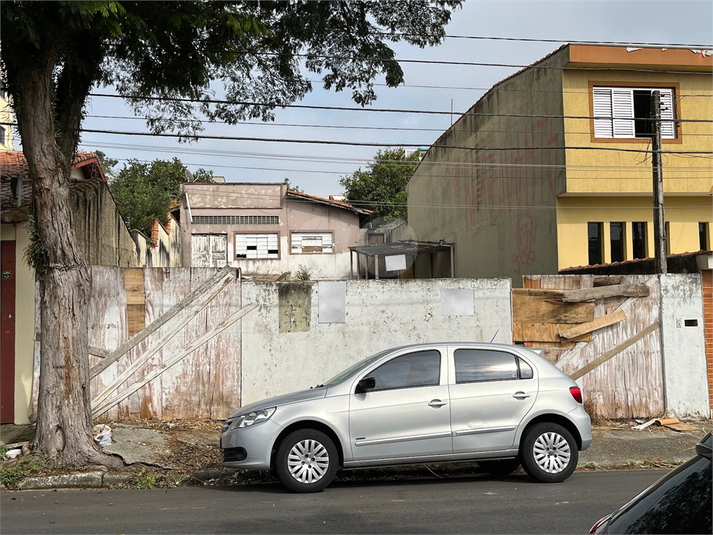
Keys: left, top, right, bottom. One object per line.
{"left": 520, "top": 422, "right": 579, "bottom": 483}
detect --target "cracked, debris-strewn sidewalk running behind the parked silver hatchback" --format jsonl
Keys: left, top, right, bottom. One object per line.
{"left": 0, "top": 420, "right": 713, "bottom": 490}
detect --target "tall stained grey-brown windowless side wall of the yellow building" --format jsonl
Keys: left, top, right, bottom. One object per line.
{"left": 406, "top": 48, "right": 566, "bottom": 286}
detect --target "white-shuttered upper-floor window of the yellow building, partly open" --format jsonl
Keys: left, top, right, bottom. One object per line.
{"left": 592, "top": 87, "right": 676, "bottom": 139}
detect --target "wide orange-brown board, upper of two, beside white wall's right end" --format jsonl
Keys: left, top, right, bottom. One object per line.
{"left": 512, "top": 289, "right": 594, "bottom": 323}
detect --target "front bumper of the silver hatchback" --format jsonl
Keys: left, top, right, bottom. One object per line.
{"left": 220, "top": 420, "right": 280, "bottom": 470}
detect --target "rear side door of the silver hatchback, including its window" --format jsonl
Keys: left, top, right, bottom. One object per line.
{"left": 449, "top": 348, "right": 537, "bottom": 453}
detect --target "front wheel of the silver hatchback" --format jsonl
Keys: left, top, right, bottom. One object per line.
{"left": 275, "top": 429, "right": 339, "bottom": 492}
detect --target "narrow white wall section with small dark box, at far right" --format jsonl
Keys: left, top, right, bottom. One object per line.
{"left": 661, "top": 273, "right": 711, "bottom": 418}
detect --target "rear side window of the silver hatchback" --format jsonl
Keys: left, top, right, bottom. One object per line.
{"left": 454, "top": 349, "right": 520, "bottom": 384}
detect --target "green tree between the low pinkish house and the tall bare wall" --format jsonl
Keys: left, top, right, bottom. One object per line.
{"left": 339, "top": 148, "right": 421, "bottom": 220}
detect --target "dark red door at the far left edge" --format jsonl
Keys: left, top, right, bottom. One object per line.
{"left": 0, "top": 241, "right": 15, "bottom": 424}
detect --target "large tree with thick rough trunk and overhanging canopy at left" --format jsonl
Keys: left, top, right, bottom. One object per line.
{"left": 0, "top": 0, "right": 461, "bottom": 465}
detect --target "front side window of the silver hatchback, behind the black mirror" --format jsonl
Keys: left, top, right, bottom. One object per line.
{"left": 369, "top": 349, "right": 441, "bottom": 391}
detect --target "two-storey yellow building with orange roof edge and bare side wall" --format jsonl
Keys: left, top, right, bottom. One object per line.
{"left": 407, "top": 45, "right": 713, "bottom": 286}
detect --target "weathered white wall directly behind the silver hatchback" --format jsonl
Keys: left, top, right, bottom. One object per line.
{"left": 242, "top": 279, "right": 512, "bottom": 405}
